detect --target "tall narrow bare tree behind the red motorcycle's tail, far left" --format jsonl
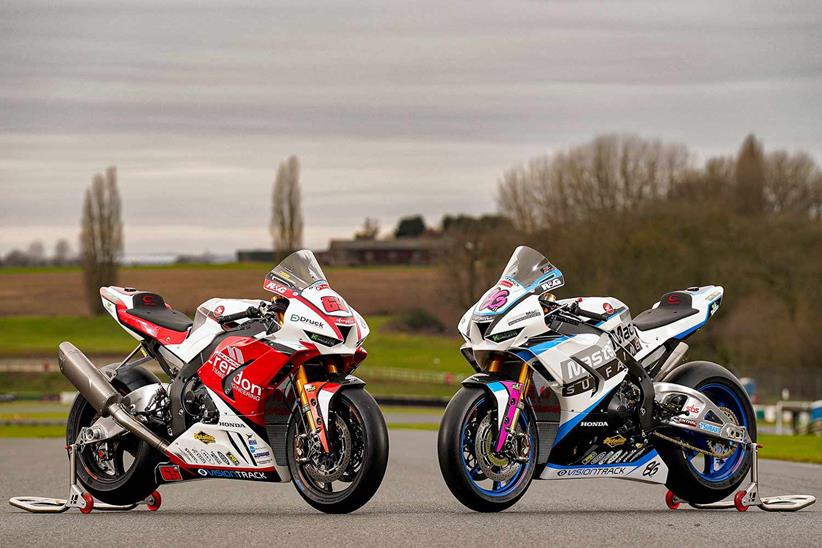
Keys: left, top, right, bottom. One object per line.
{"left": 80, "top": 167, "right": 123, "bottom": 314}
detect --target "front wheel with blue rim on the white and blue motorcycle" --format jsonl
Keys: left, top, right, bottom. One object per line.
{"left": 437, "top": 386, "right": 538, "bottom": 512}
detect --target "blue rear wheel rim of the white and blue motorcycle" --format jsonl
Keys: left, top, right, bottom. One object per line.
{"left": 683, "top": 383, "right": 750, "bottom": 483}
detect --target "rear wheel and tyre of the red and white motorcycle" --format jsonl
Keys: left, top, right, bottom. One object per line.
{"left": 66, "top": 395, "right": 161, "bottom": 505}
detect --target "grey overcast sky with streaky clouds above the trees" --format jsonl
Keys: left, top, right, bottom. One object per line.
{"left": 0, "top": 0, "right": 822, "bottom": 254}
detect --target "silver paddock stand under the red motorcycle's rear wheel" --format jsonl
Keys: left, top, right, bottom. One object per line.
{"left": 9, "top": 442, "right": 162, "bottom": 514}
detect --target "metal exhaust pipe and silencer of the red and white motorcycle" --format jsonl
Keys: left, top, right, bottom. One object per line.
{"left": 57, "top": 342, "right": 168, "bottom": 455}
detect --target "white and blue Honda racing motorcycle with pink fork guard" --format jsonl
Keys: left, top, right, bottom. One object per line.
{"left": 438, "top": 247, "right": 758, "bottom": 512}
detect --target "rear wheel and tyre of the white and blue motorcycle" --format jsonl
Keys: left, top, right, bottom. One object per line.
{"left": 654, "top": 362, "right": 756, "bottom": 504}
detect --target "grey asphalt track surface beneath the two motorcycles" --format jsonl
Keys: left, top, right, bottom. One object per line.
{"left": 0, "top": 430, "right": 822, "bottom": 547}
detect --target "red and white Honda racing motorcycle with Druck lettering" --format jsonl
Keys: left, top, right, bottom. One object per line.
{"left": 59, "top": 250, "right": 388, "bottom": 513}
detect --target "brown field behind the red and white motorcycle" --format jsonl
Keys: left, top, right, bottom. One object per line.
{"left": 0, "top": 263, "right": 457, "bottom": 326}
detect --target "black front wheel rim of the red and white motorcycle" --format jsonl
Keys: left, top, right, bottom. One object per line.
{"left": 293, "top": 398, "right": 366, "bottom": 499}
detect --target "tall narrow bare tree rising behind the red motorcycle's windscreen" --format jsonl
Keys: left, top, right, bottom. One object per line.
{"left": 271, "top": 156, "right": 303, "bottom": 256}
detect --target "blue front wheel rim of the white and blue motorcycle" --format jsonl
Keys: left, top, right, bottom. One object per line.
{"left": 460, "top": 397, "right": 534, "bottom": 497}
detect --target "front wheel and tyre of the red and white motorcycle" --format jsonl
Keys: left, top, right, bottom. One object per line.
{"left": 288, "top": 389, "right": 388, "bottom": 514}
